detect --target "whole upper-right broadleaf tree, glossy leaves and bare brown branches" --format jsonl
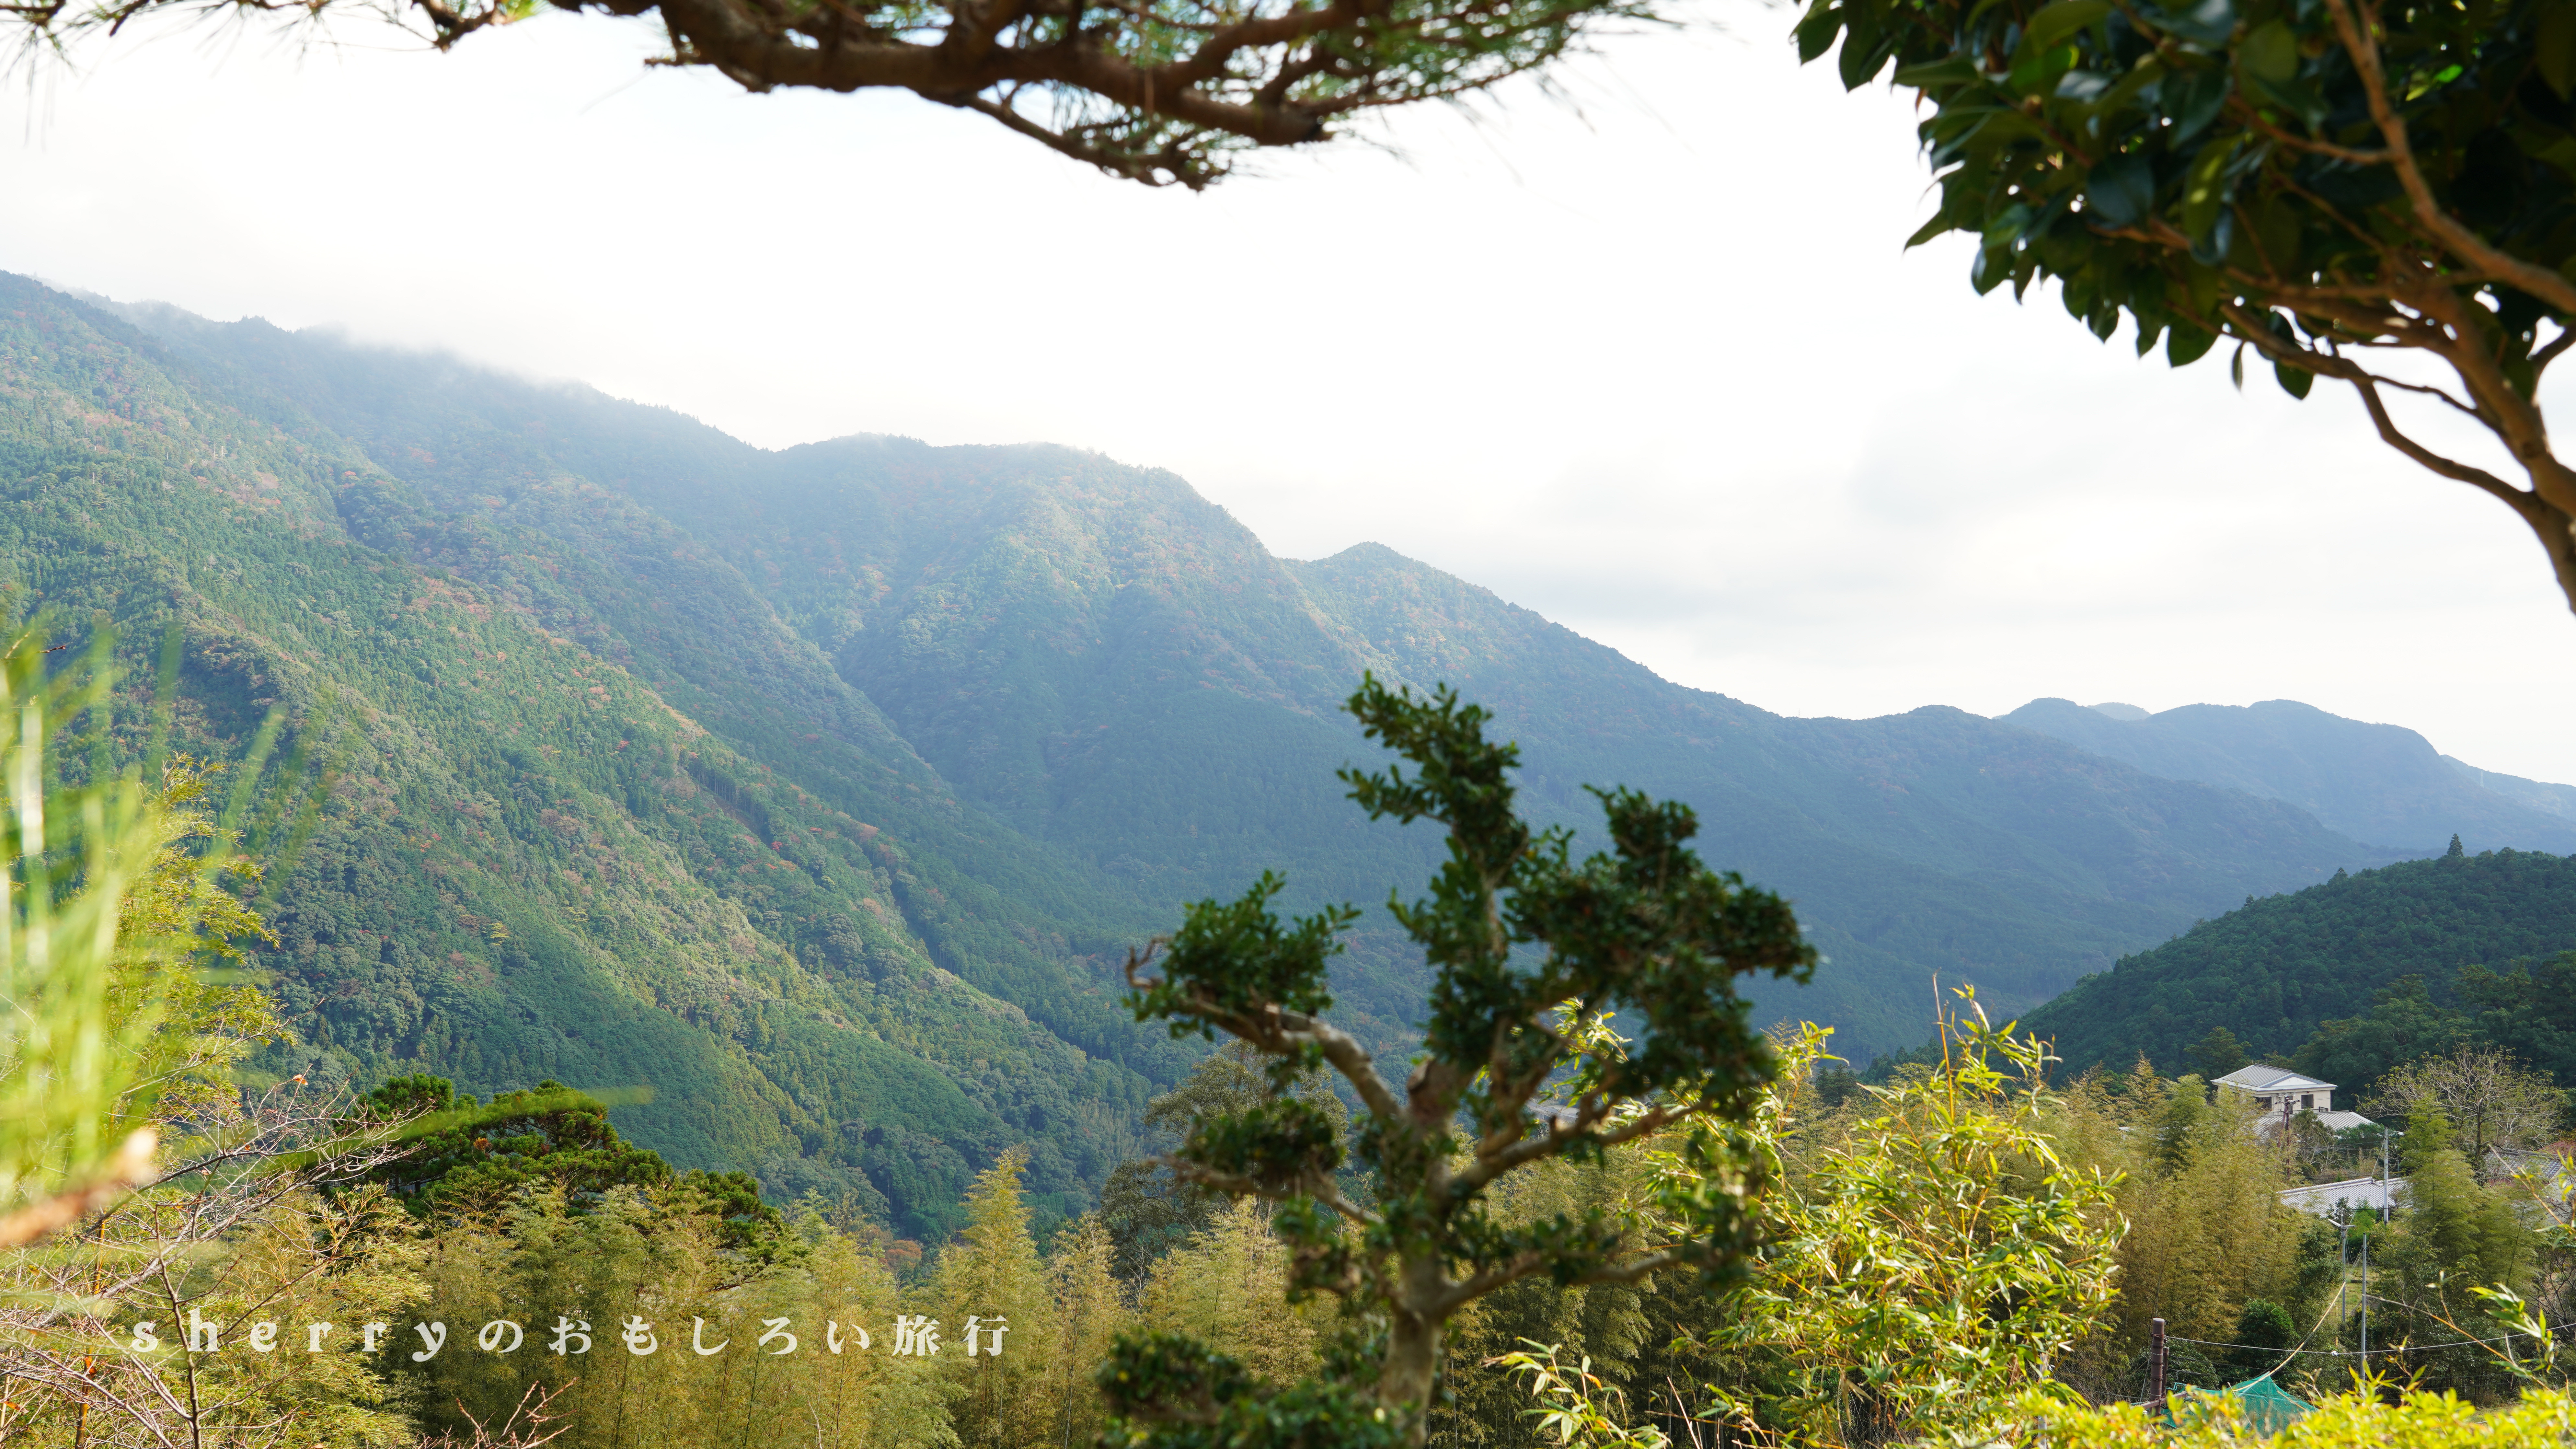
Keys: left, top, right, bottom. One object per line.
{"left": 1798, "top": 0, "right": 2576, "bottom": 606}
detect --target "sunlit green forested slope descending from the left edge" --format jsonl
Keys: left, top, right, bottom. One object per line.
{"left": 0, "top": 278, "right": 1185, "bottom": 1233}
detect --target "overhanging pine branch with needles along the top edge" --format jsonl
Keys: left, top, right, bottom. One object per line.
{"left": 0, "top": 0, "right": 1654, "bottom": 191}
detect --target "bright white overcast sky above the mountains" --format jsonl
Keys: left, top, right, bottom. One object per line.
{"left": 0, "top": 0, "right": 2576, "bottom": 781}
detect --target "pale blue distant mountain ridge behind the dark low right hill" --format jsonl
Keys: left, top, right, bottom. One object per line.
{"left": 2002, "top": 699, "right": 2576, "bottom": 856}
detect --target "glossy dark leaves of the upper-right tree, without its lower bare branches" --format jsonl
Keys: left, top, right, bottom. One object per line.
{"left": 1798, "top": 0, "right": 2576, "bottom": 307}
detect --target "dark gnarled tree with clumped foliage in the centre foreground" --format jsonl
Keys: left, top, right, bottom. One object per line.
{"left": 1118, "top": 678, "right": 1816, "bottom": 1444}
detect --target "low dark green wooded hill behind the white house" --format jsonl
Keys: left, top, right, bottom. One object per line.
{"left": 2027, "top": 851, "right": 2576, "bottom": 1072}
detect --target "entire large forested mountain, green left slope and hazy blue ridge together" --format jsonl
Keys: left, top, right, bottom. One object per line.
{"left": 0, "top": 268, "right": 2524, "bottom": 1217}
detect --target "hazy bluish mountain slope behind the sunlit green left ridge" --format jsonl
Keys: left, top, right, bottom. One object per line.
{"left": 100, "top": 296, "right": 2421, "bottom": 1055}
